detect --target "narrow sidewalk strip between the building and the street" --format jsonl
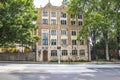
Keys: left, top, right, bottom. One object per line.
{"left": 0, "top": 61, "right": 120, "bottom": 64}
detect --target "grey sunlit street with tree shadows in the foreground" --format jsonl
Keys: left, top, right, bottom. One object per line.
{"left": 0, "top": 63, "right": 120, "bottom": 80}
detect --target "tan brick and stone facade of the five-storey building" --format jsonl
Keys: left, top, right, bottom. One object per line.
{"left": 37, "top": 2, "right": 88, "bottom": 61}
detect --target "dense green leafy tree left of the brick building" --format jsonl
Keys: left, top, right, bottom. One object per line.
{"left": 0, "top": 0, "right": 36, "bottom": 45}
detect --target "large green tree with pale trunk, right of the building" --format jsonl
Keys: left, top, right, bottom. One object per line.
{"left": 68, "top": 0, "right": 120, "bottom": 60}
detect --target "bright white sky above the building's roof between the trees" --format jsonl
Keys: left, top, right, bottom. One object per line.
{"left": 34, "top": 0, "right": 63, "bottom": 8}
